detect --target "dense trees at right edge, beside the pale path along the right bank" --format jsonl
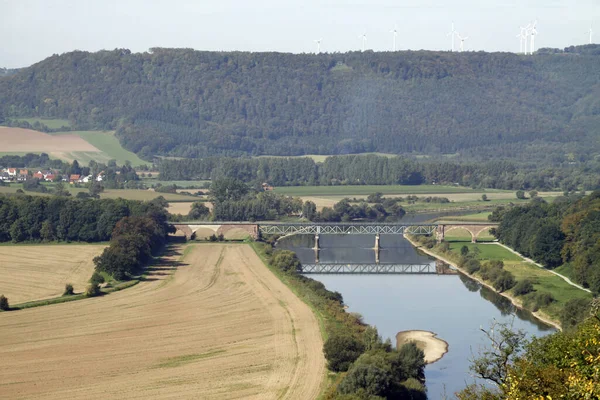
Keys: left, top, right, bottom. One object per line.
{"left": 490, "top": 191, "right": 600, "bottom": 295}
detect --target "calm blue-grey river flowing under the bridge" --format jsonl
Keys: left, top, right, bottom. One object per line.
{"left": 277, "top": 214, "right": 554, "bottom": 399}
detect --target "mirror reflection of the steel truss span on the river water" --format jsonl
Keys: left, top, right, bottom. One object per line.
{"left": 301, "top": 263, "right": 439, "bottom": 274}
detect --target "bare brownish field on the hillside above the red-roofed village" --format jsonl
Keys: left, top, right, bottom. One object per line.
{"left": 0, "top": 127, "right": 100, "bottom": 153}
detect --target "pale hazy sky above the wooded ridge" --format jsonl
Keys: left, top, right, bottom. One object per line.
{"left": 0, "top": 0, "right": 600, "bottom": 68}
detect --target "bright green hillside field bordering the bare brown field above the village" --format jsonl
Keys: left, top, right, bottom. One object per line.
{"left": 52, "top": 131, "right": 148, "bottom": 167}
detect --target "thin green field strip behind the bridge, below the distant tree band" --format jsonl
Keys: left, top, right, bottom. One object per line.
{"left": 275, "top": 185, "right": 497, "bottom": 196}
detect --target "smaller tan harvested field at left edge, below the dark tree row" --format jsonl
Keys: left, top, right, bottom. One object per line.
{"left": 0, "top": 245, "right": 105, "bottom": 304}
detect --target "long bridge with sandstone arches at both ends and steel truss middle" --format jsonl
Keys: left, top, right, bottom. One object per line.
{"left": 171, "top": 221, "right": 498, "bottom": 242}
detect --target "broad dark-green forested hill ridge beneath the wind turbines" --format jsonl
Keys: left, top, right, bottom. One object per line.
{"left": 0, "top": 45, "right": 600, "bottom": 157}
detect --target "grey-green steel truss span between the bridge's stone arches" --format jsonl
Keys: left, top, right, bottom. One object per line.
{"left": 258, "top": 223, "right": 438, "bottom": 235}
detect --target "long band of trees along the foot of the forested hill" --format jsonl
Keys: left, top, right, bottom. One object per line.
{"left": 158, "top": 155, "right": 600, "bottom": 191}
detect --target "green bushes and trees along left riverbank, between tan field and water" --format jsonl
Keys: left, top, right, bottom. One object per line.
{"left": 253, "top": 241, "right": 427, "bottom": 400}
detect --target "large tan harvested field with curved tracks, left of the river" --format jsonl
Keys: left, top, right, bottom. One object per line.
{"left": 0, "top": 244, "right": 325, "bottom": 399}
